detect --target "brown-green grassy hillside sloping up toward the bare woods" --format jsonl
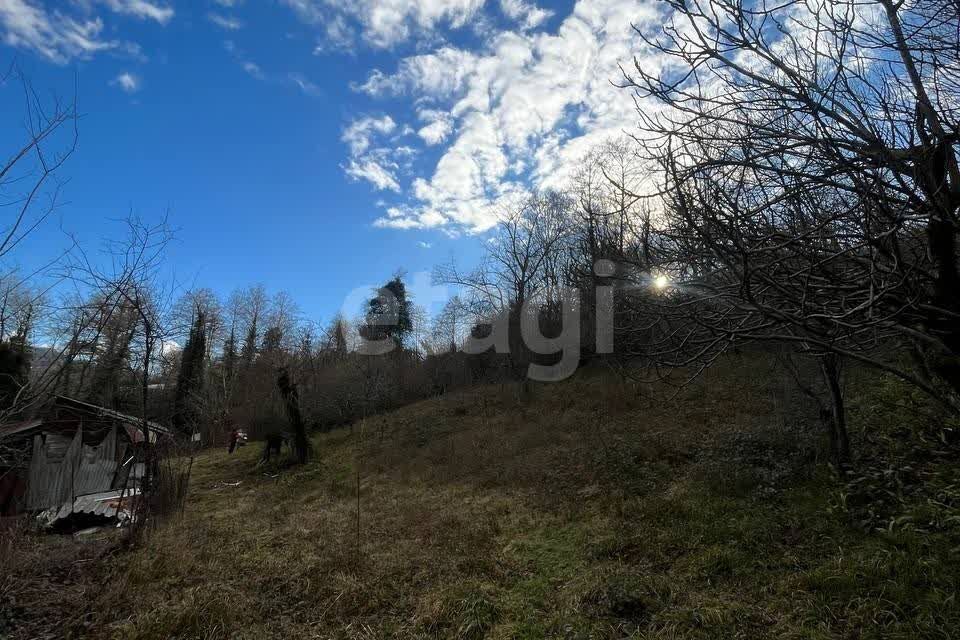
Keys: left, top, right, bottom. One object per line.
{"left": 6, "top": 358, "right": 960, "bottom": 639}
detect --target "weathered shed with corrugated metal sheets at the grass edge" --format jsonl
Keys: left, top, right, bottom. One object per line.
{"left": 0, "top": 396, "right": 173, "bottom": 515}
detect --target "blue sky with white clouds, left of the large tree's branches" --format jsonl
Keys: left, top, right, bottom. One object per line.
{"left": 0, "top": 0, "right": 654, "bottom": 319}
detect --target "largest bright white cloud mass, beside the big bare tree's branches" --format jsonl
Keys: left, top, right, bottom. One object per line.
{"left": 356, "top": 0, "right": 659, "bottom": 232}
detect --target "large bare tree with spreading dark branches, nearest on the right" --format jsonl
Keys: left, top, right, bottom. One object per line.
{"left": 624, "top": 0, "right": 960, "bottom": 456}
